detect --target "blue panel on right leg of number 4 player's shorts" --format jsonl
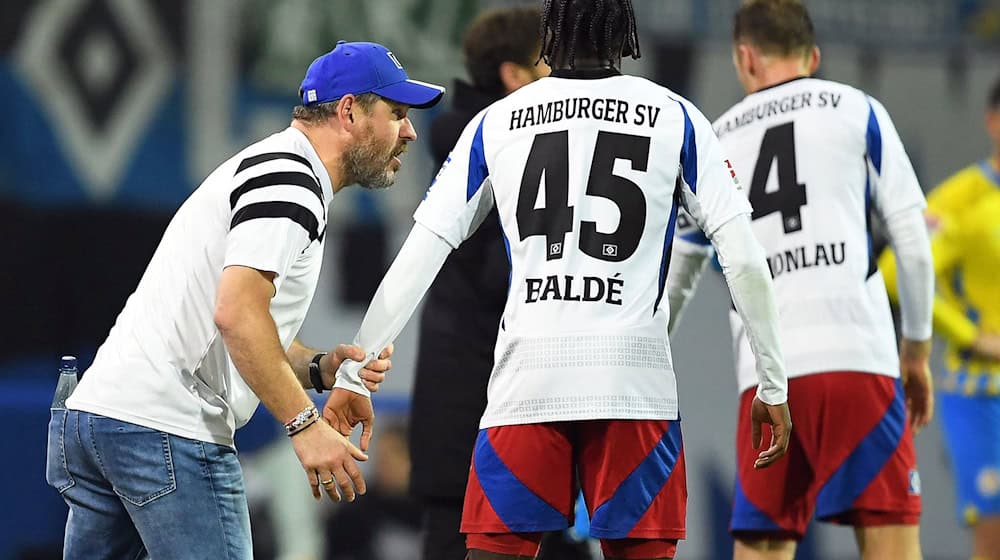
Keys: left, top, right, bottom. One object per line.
{"left": 816, "top": 379, "right": 906, "bottom": 519}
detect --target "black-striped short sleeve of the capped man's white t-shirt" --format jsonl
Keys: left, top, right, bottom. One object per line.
{"left": 223, "top": 158, "right": 326, "bottom": 284}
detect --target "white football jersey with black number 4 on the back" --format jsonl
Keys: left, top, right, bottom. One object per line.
{"left": 708, "top": 78, "right": 925, "bottom": 391}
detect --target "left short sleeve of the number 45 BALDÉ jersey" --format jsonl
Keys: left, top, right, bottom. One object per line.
{"left": 413, "top": 109, "right": 493, "bottom": 248}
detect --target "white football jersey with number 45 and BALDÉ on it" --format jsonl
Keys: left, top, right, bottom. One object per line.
{"left": 414, "top": 71, "right": 750, "bottom": 428}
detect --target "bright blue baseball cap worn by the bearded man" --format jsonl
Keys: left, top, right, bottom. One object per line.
{"left": 299, "top": 41, "right": 444, "bottom": 109}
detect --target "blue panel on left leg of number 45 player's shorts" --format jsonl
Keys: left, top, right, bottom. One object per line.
{"left": 474, "top": 430, "right": 569, "bottom": 533}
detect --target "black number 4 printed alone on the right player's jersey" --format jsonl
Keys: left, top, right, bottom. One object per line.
{"left": 750, "top": 122, "right": 806, "bottom": 233}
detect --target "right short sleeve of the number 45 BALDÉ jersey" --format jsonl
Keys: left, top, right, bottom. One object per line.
{"left": 677, "top": 100, "right": 753, "bottom": 241}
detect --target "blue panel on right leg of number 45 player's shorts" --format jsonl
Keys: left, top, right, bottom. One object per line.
{"left": 590, "top": 420, "right": 683, "bottom": 539}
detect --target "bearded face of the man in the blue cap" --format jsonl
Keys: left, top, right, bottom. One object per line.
{"left": 345, "top": 99, "right": 417, "bottom": 189}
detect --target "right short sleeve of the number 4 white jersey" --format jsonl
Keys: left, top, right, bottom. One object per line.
{"left": 865, "top": 97, "right": 927, "bottom": 218}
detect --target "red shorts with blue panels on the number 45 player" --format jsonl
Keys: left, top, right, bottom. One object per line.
{"left": 462, "top": 420, "right": 687, "bottom": 558}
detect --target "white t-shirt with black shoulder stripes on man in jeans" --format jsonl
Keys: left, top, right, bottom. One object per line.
{"left": 67, "top": 128, "right": 333, "bottom": 445}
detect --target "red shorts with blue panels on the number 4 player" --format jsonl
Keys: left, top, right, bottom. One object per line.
{"left": 730, "top": 372, "right": 920, "bottom": 539}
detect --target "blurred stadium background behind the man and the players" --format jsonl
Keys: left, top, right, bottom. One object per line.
{"left": 0, "top": 0, "right": 1000, "bottom": 559}
